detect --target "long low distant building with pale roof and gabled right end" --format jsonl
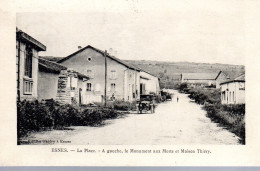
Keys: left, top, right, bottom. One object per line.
{"left": 181, "top": 71, "right": 229, "bottom": 88}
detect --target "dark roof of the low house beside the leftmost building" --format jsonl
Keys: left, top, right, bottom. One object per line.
{"left": 39, "top": 58, "right": 89, "bottom": 79}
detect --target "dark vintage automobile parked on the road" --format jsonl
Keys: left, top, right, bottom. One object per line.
{"left": 136, "top": 94, "right": 155, "bottom": 114}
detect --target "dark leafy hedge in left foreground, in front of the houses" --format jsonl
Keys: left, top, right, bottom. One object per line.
{"left": 17, "top": 101, "right": 121, "bottom": 138}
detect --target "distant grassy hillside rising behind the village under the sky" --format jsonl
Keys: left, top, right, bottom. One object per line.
{"left": 125, "top": 60, "right": 245, "bottom": 87}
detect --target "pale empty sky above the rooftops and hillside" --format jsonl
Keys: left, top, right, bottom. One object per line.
{"left": 16, "top": 0, "right": 245, "bottom": 65}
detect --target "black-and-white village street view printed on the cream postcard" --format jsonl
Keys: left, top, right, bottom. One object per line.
{"left": 16, "top": 9, "right": 246, "bottom": 145}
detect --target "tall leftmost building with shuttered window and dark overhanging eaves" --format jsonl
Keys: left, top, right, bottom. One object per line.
{"left": 16, "top": 28, "right": 46, "bottom": 101}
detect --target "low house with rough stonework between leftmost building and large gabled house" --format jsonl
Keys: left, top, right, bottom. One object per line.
{"left": 37, "top": 58, "right": 89, "bottom": 105}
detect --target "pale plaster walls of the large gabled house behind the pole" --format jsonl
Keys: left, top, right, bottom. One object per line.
{"left": 61, "top": 48, "right": 140, "bottom": 103}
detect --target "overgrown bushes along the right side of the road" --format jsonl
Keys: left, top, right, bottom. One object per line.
{"left": 178, "top": 83, "right": 245, "bottom": 144}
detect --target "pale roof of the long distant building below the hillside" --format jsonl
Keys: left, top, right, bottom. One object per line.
{"left": 182, "top": 73, "right": 219, "bottom": 80}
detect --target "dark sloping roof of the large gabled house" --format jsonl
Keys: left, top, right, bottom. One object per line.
{"left": 57, "top": 45, "right": 140, "bottom": 71}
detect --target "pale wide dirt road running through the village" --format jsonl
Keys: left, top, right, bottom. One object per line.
{"left": 21, "top": 91, "right": 239, "bottom": 145}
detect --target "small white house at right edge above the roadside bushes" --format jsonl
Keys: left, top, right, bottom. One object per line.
{"left": 220, "top": 74, "right": 245, "bottom": 104}
